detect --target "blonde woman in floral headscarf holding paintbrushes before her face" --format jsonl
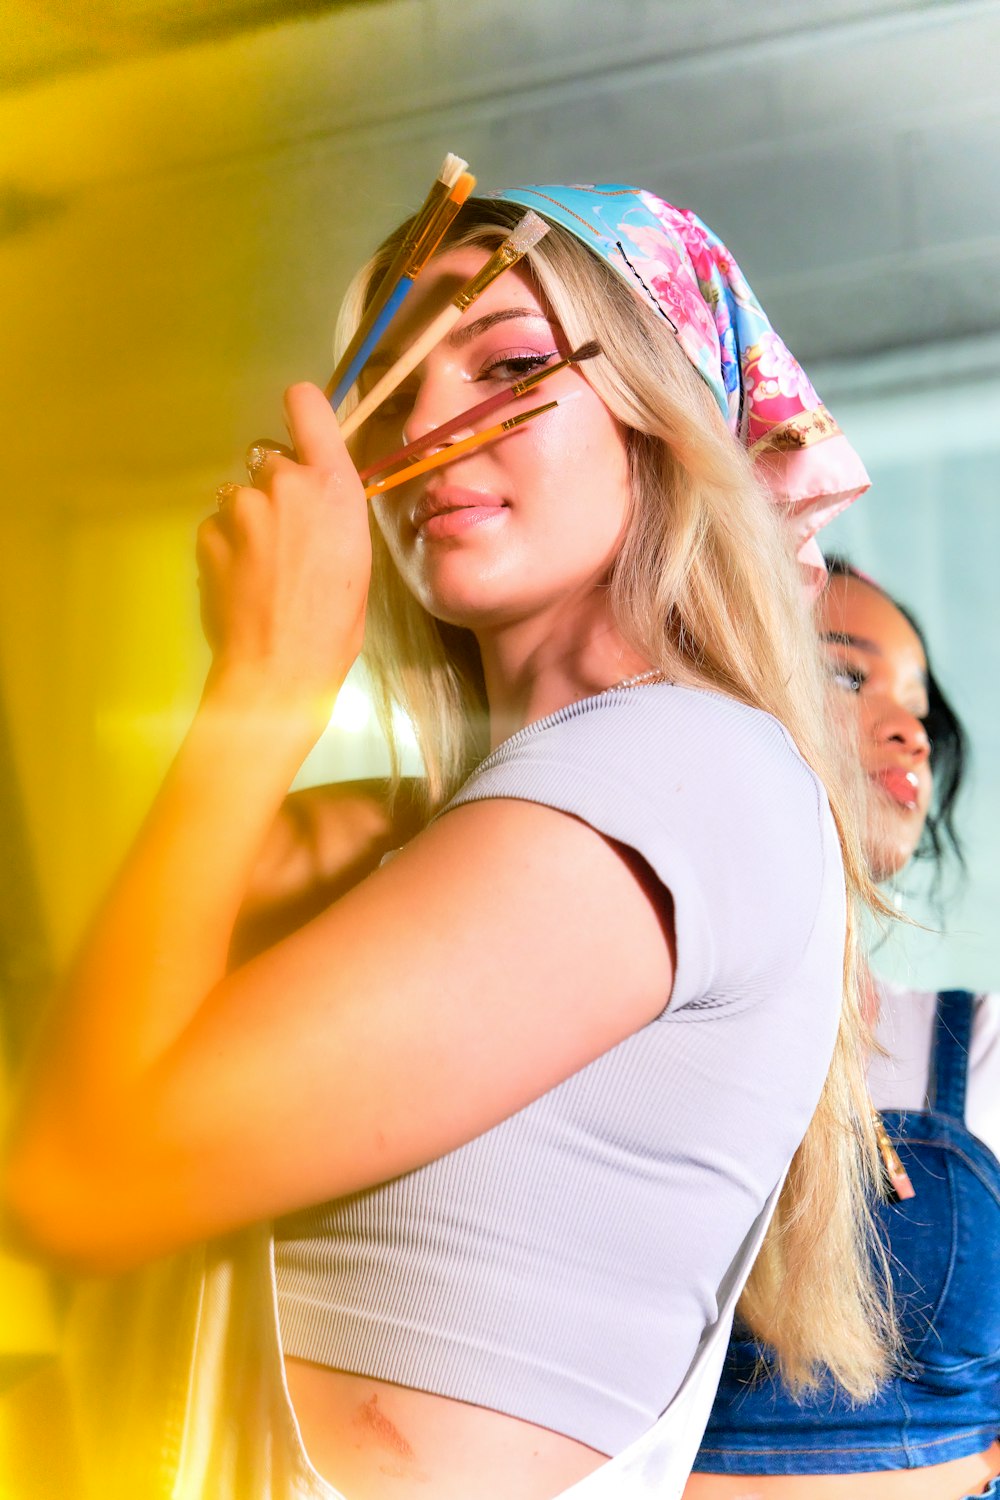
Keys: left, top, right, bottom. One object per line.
{"left": 9, "top": 188, "right": 886, "bottom": 1500}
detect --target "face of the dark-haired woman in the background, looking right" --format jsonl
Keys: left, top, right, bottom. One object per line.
{"left": 819, "top": 575, "right": 933, "bottom": 881}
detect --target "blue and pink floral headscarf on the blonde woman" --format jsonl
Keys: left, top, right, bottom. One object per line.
{"left": 490, "top": 183, "right": 871, "bottom": 581}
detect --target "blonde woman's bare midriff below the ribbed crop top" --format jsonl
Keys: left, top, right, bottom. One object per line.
{"left": 285, "top": 1358, "right": 607, "bottom": 1500}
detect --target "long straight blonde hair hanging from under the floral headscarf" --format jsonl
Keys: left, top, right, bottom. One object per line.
{"left": 339, "top": 200, "right": 897, "bottom": 1398}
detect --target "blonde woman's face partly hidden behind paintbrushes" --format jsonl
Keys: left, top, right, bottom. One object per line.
{"left": 363, "top": 248, "right": 630, "bottom": 630}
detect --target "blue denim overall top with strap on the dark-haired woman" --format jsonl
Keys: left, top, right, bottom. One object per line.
{"left": 694, "top": 990, "right": 1000, "bottom": 1476}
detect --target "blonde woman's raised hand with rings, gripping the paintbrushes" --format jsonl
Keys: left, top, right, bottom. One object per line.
{"left": 198, "top": 384, "right": 372, "bottom": 725}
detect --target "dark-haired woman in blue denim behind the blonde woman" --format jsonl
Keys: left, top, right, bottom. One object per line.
{"left": 685, "top": 561, "right": 1000, "bottom": 1500}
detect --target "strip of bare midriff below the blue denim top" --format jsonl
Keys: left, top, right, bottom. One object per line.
{"left": 684, "top": 1442, "right": 1000, "bottom": 1500}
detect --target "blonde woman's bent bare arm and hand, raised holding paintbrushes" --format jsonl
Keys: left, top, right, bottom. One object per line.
{"left": 7, "top": 387, "right": 673, "bottom": 1268}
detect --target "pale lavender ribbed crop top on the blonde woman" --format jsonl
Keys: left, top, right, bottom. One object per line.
{"left": 276, "top": 684, "right": 844, "bottom": 1455}
